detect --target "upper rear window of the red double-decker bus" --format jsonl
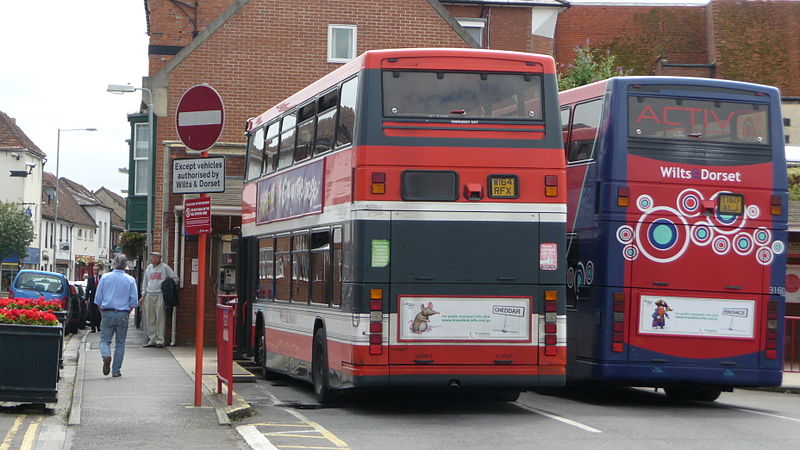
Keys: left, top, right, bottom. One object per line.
{"left": 383, "top": 70, "right": 544, "bottom": 120}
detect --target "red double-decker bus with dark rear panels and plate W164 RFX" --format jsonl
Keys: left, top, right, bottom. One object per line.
{"left": 239, "top": 49, "right": 566, "bottom": 401}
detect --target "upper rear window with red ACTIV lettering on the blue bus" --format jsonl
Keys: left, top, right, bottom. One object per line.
{"left": 628, "top": 95, "right": 769, "bottom": 145}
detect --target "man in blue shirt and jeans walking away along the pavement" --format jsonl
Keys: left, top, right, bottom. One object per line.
{"left": 94, "top": 255, "right": 139, "bottom": 377}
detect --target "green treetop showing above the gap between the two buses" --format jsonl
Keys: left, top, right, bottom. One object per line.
{"left": 558, "top": 42, "right": 631, "bottom": 91}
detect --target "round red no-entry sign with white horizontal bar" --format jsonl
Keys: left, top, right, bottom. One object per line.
{"left": 175, "top": 84, "right": 225, "bottom": 151}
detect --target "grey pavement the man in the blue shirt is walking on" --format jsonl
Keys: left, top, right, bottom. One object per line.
{"left": 35, "top": 321, "right": 800, "bottom": 450}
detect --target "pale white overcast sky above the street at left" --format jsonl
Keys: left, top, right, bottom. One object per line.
{"left": 0, "top": 0, "right": 148, "bottom": 196}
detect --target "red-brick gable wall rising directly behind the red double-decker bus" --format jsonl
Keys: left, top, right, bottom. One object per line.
{"left": 151, "top": 0, "right": 467, "bottom": 344}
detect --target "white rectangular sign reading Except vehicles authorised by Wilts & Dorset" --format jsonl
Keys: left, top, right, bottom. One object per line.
{"left": 172, "top": 156, "right": 225, "bottom": 194}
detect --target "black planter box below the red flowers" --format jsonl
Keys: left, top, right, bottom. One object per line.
{"left": 0, "top": 324, "right": 63, "bottom": 403}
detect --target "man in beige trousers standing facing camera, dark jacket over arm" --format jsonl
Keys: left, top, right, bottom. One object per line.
{"left": 139, "top": 252, "right": 178, "bottom": 348}
